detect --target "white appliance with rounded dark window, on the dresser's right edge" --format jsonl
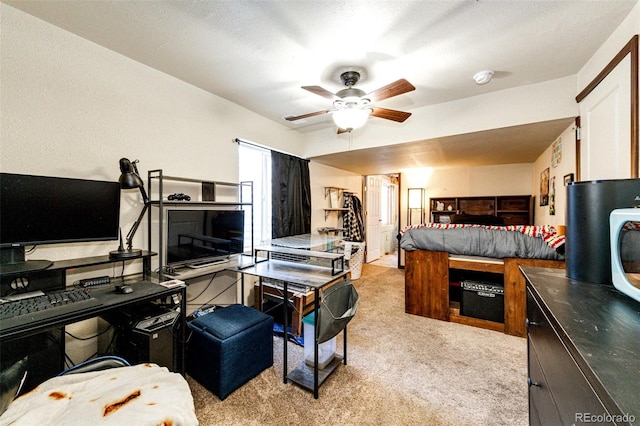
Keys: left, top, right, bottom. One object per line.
{"left": 609, "top": 208, "right": 640, "bottom": 302}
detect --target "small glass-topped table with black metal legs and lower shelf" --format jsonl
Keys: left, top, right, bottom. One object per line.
{"left": 229, "top": 259, "right": 349, "bottom": 399}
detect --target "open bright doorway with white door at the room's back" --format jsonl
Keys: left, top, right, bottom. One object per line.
{"left": 364, "top": 173, "right": 400, "bottom": 268}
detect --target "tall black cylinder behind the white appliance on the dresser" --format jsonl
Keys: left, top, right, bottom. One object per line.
{"left": 565, "top": 179, "right": 640, "bottom": 284}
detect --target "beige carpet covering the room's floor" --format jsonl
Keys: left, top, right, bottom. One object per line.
{"left": 188, "top": 265, "right": 528, "bottom": 426}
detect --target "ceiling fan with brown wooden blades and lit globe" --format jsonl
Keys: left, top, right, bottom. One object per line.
{"left": 285, "top": 71, "right": 415, "bottom": 133}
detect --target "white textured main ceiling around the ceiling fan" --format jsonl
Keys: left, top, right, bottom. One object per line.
{"left": 2, "top": 0, "right": 636, "bottom": 173}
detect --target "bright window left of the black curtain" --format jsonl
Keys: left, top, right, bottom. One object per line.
{"left": 238, "top": 143, "right": 272, "bottom": 245}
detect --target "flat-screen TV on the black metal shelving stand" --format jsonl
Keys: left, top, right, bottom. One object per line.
{"left": 166, "top": 209, "right": 245, "bottom": 266}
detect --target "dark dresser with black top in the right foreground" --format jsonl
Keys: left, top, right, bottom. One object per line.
{"left": 521, "top": 267, "right": 640, "bottom": 425}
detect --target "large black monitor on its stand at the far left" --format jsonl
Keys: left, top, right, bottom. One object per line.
{"left": 0, "top": 173, "right": 120, "bottom": 272}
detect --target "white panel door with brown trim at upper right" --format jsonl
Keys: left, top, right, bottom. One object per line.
{"left": 580, "top": 55, "right": 631, "bottom": 180}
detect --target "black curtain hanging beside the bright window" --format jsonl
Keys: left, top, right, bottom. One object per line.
{"left": 271, "top": 151, "right": 311, "bottom": 238}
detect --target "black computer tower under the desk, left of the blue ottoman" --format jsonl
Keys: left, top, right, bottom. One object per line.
{"left": 103, "top": 303, "right": 179, "bottom": 372}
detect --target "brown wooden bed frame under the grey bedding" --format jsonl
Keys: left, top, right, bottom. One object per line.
{"left": 405, "top": 250, "right": 565, "bottom": 337}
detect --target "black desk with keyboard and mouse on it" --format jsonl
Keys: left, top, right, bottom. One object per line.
{"left": 0, "top": 275, "right": 186, "bottom": 388}
